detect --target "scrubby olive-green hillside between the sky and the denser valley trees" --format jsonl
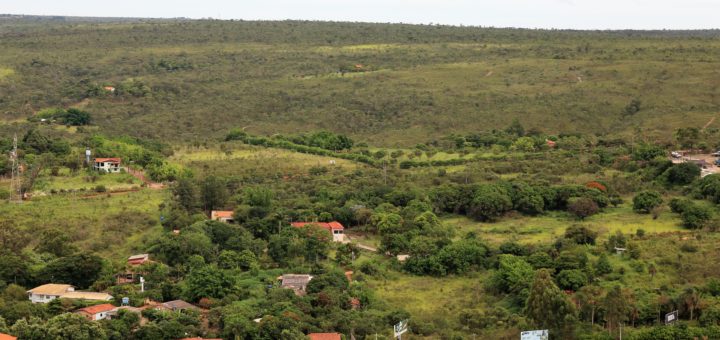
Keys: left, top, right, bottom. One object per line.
{"left": 0, "top": 19, "right": 720, "bottom": 146}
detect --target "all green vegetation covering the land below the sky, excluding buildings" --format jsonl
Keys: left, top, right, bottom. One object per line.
{"left": 0, "top": 19, "right": 720, "bottom": 339}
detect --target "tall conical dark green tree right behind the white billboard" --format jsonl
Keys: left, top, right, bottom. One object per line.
{"left": 525, "top": 269, "right": 576, "bottom": 339}
